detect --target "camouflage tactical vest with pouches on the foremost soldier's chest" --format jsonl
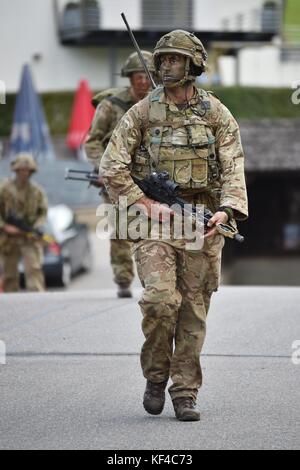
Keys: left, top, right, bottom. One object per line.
{"left": 132, "top": 87, "right": 219, "bottom": 192}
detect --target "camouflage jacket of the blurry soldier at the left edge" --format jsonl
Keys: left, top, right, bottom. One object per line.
{"left": 0, "top": 179, "right": 48, "bottom": 229}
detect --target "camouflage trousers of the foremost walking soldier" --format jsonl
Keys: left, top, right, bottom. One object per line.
{"left": 135, "top": 235, "right": 224, "bottom": 400}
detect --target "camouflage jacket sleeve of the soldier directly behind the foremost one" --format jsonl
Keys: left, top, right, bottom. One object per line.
{"left": 84, "top": 88, "right": 134, "bottom": 168}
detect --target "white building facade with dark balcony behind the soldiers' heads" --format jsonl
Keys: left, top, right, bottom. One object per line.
{"left": 0, "top": 0, "right": 300, "bottom": 92}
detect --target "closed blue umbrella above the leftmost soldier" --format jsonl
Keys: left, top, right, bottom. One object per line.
{"left": 10, "top": 65, "right": 55, "bottom": 161}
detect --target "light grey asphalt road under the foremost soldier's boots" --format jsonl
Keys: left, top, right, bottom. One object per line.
{"left": 0, "top": 280, "right": 300, "bottom": 450}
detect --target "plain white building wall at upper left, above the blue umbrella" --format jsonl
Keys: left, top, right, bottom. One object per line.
{"left": 0, "top": 0, "right": 134, "bottom": 92}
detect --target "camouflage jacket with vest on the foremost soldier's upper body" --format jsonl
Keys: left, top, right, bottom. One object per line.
{"left": 100, "top": 89, "right": 248, "bottom": 220}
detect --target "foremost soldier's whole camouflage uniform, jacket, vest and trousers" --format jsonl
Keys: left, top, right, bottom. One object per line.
{"left": 101, "top": 32, "right": 248, "bottom": 404}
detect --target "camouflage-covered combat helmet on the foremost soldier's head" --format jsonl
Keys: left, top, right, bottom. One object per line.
{"left": 153, "top": 29, "right": 207, "bottom": 86}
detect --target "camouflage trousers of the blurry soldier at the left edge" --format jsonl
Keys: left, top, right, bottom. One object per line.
{"left": 2, "top": 237, "right": 45, "bottom": 292}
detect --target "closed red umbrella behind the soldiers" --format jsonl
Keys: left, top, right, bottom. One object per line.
{"left": 67, "top": 80, "right": 95, "bottom": 150}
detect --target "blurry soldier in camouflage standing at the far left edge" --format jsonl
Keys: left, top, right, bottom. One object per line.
{"left": 0, "top": 153, "right": 48, "bottom": 292}
